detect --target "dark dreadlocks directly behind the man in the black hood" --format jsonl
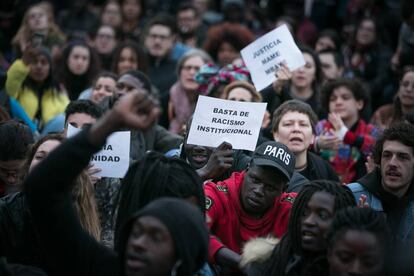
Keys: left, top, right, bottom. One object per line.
{"left": 115, "top": 152, "right": 205, "bottom": 252}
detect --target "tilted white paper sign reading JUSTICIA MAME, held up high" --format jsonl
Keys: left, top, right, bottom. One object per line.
{"left": 241, "top": 25, "right": 305, "bottom": 91}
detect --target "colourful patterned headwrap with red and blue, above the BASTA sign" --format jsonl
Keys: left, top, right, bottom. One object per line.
{"left": 195, "top": 63, "right": 250, "bottom": 95}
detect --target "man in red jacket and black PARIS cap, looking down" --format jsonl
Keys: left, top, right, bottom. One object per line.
{"left": 205, "top": 141, "right": 296, "bottom": 268}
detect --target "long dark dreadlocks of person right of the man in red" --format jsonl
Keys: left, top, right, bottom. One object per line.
{"left": 265, "top": 180, "right": 355, "bottom": 275}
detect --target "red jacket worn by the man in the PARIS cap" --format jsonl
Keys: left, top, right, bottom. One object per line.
{"left": 204, "top": 172, "right": 296, "bottom": 263}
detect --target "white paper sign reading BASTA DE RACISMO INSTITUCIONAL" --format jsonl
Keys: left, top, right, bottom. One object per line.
{"left": 187, "top": 96, "right": 267, "bottom": 151}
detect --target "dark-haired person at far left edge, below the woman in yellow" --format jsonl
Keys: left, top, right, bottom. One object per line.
{"left": 0, "top": 120, "right": 33, "bottom": 197}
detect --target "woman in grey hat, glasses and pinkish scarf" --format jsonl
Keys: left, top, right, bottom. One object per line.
{"left": 168, "top": 50, "right": 211, "bottom": 134}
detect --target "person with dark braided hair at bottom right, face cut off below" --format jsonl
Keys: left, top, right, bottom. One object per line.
{"left": 327, "top": 207, "right": 391, "bottom": 276}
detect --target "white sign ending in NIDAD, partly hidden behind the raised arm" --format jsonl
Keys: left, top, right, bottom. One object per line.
{"left": 67, "top": 124, "right": 131, "bottom": 178}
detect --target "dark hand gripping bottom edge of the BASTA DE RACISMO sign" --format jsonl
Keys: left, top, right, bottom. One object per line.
{"left": 198, "top": 142, "right": 234, "bottom": 180}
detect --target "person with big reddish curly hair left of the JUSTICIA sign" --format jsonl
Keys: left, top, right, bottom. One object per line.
{"left": 204, "top": 23, "right": 255, "bottom": 67}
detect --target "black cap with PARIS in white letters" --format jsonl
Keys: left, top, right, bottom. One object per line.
{"left": 252, "top": 141, "right": 295, "bottom": 180}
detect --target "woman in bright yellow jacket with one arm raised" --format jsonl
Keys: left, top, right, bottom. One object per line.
{"left": 6, "top": 47, "right": 69, "bottom": 134}
